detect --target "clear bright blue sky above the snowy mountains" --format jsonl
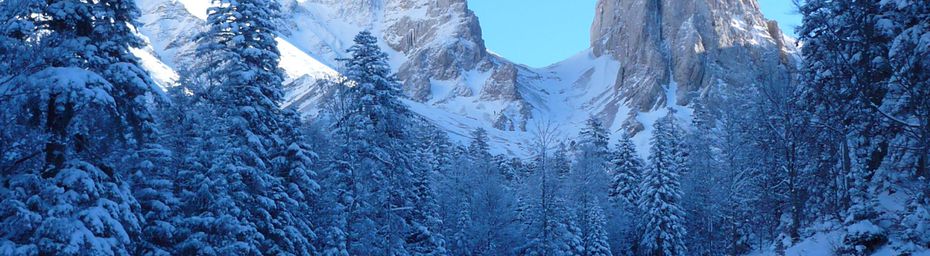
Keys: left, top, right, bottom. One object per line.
{"left": 468, "top": 0, "right": 801, "bottom": 67}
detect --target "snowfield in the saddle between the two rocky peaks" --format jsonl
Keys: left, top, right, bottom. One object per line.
{"left": 405, "top": 47, "right": 692, "bottom": 158}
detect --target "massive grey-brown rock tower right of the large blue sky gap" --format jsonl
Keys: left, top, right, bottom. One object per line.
{"left": 591, "top": 0, "right": 796, "bottom": 110}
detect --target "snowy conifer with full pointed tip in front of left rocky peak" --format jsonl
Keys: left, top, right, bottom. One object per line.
{"left": 335, "top": 31, "right": 444, "bottom": 255}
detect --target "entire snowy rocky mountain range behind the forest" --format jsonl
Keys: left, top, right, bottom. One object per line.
{"left": 137, "top": 0, "right": 796, "bottom": 155}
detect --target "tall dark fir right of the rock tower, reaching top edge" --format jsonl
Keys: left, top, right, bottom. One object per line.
{"left": 795, "top": 1, "right": 896, "bottom": 253}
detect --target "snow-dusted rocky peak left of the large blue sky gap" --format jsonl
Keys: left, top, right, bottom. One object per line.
{"left": 280, "top": 0, "right": 531, "bottom": 129}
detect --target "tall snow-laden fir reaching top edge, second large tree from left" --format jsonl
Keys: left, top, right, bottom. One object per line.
{"left": 172, "top": 0, "right": 316, "bottom": 255}
